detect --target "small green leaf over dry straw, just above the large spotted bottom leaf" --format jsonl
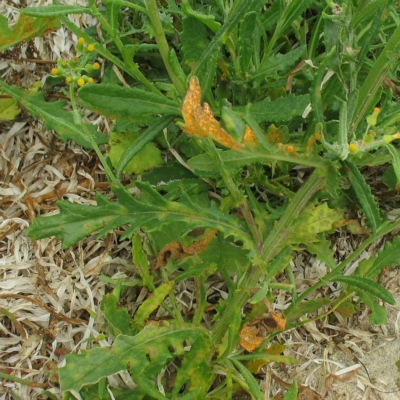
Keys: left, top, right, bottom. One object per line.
{"left": 101, "top": 293, "right": 133, "bottom": 336}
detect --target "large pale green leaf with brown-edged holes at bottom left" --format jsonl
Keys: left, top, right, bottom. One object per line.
{"left": 59, "top": 325, "right": 210, "bottom": 399}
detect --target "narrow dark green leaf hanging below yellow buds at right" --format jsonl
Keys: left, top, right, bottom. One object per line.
{"left": 343, "top": 161, "right": 382, "bottom": 234}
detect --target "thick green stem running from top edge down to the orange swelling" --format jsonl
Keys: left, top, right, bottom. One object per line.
{"left": 144, "top": 0, "right": 186, "bottom": 98}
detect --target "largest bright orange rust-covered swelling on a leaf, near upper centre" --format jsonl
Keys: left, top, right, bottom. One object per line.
{"left": 182, "top": 76, "right": 242, "bottom": 150}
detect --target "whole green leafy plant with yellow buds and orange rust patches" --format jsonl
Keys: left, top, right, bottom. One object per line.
{"left": 1, "top": 0, "right": 400, "bottom": 399}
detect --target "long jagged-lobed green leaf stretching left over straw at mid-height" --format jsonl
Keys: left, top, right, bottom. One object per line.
{"left": 27, "top": 182, "right": 253, "bottom": 249}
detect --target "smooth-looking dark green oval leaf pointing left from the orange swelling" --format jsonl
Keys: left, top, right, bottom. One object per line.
{"left": 78, "top": 85, "right": 181, "bottom": 120}
